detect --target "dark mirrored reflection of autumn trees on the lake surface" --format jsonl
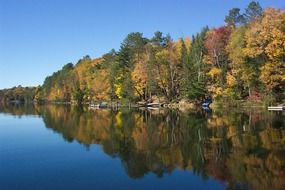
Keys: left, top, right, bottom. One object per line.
{"left": 0, "top": 105, "right": 285, "bottom": 189}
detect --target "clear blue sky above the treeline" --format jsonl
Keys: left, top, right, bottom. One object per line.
{"left": 0, "top": 0, "right": 285, "bottom": 89}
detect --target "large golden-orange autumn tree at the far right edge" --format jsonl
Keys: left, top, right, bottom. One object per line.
{"left": 244, "top": 8, "right": 285, "bottom": 99}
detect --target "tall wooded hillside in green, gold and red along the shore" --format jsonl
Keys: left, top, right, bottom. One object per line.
{"left": 2, "top": 1, "right": 285, "bottom": 103}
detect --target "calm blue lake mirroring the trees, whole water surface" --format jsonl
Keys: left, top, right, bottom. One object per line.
{"left": 0, "top": 105, "right": 285, "bottom": 190}
